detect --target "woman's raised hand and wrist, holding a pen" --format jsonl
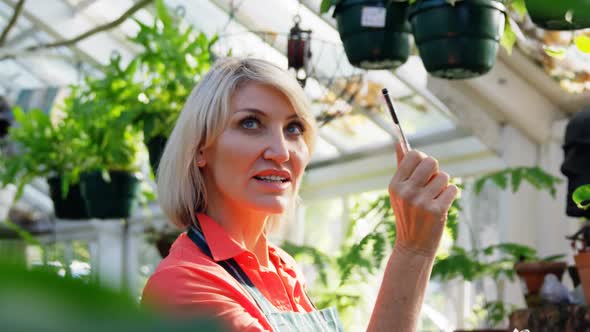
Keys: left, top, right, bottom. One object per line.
{"left": 389, "top": 144, "right": 458, "bottom": 256}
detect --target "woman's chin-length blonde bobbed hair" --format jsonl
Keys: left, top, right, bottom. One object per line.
{"left": 157, "top": 58, "right": 317, "bottom": 228}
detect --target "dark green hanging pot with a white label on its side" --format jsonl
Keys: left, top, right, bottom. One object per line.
{"left": 334, "top": 0, "right": 411, "bottom": 69}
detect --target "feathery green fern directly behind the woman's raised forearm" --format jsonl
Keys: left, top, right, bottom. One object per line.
{"left": 281, "top": 193, "right": 461, "bottom": 322}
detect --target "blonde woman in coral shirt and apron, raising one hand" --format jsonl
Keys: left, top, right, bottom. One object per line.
{"left": 143, "top": 59, "right": 457, "bottom": 331}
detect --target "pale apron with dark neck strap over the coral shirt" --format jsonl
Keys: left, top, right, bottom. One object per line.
{"left": 187, "top": 226, "right": 343, "bottom": 332}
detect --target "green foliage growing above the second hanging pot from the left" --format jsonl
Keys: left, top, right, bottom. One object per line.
{"left": 63, "top": 54, "right": 142, "bottom": 173}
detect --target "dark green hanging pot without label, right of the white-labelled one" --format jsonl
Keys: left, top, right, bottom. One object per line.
{"left": 409, "top": 0, "right": 506, "bottom": 79}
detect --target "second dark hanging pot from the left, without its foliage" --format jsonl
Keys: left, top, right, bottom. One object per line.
{"left": 80, "top": 171, "right": 139, "bottom": 219}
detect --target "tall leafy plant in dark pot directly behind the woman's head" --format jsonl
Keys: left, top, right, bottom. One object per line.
{"left": 130, "top": 0, "right": 217, "bottom": 172}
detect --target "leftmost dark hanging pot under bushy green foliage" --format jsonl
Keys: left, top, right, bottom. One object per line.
{"left": 47, "top": 176, "right": 89, "bottom": 219}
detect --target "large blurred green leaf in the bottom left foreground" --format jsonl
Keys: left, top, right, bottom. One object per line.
{"left": 0, "top": 262, "right": 222, "bottom": 332}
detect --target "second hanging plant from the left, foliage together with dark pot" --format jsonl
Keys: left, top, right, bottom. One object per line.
{"left": 64, "top": 54, "right": 143, "bottom": 219}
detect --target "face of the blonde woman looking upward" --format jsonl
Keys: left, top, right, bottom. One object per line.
{"left": 200, "top": 82, "right": 309, "bottom": 214}
